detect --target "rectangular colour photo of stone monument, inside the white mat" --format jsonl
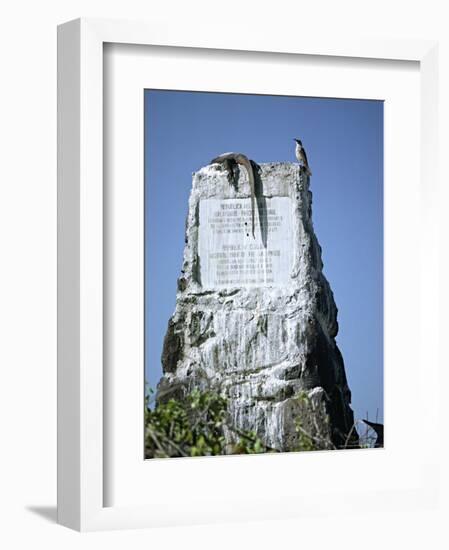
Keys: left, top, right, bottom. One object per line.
{"left": 144, "top": 90, "right": 384, "bottom": 458}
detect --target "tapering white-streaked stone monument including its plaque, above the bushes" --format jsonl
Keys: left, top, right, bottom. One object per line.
{"left": 157, "top": 163, "right": 356, "bottom": 451}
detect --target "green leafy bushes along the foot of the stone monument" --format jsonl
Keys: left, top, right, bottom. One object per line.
{"left": 145, "top": 389, "right": 370, "bottom": 458}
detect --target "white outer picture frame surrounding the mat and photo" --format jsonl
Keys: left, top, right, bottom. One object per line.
{"left": 58, "top": 19, "right": 441, "bottom": 530}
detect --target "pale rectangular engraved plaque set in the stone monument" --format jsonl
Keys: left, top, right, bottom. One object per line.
{"left": 198, "top": 197, "right": 294, "bottom": 289}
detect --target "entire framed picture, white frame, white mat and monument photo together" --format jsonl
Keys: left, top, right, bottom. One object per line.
{"left": 58, "top": 20, "right": 440, "bottom": 530}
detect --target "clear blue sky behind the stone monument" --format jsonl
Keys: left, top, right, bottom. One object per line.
{"left": 144, "top": 90, "right": 383, "bottom": 422}
